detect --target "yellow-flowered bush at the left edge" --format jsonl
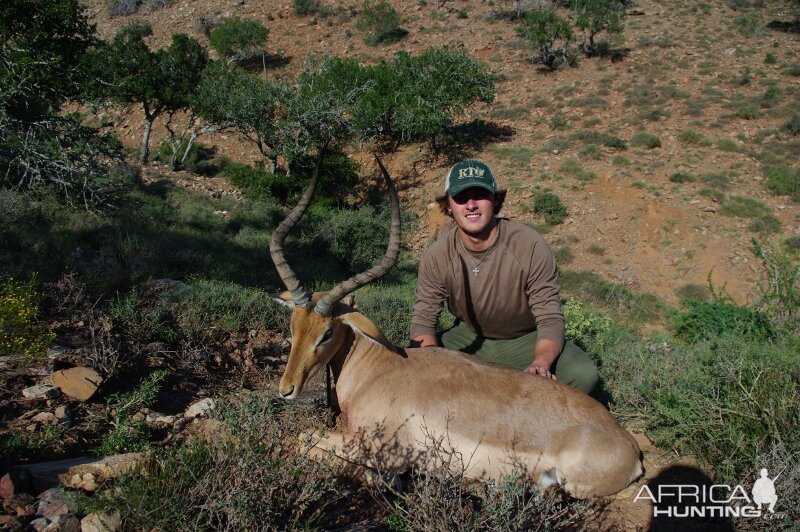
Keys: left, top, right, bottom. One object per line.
{"left": 0, "top": 276, "right": 56, "bottom": 365}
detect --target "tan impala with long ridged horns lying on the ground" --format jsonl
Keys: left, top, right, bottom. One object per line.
{"left": 270, "top": 157, "right": 642, "bottom": 498}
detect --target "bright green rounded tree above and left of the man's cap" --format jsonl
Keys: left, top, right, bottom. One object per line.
{"left": 392, "top": 46, "right": 496, "bottom": 148}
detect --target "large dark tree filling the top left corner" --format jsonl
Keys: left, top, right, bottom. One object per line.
{"left": 0, "top": 0, "right": 128, "bottom": 209}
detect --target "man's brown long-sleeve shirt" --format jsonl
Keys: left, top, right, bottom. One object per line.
{"left": 411, "top": 218, "right": 564, "bottom": 346}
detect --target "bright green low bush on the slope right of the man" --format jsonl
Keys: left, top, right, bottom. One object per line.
{"left": 672, "top": 299, "right": 773, "bottom": 343}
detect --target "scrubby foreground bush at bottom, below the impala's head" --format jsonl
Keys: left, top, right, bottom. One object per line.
{"left": 95, "top": 393, "right": 341, "bottom": 530}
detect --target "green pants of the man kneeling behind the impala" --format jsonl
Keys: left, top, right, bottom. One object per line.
{"left": 439, "top": 322, "right": 598, "bottom": 393}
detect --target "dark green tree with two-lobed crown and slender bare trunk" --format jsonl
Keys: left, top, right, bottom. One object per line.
{"left": 94, "top": 23, "right": 207, "bottom": 162}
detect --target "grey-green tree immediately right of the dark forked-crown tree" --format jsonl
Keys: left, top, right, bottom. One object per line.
{"left": 194, "top": 63, "right": 285, "bottom": 170}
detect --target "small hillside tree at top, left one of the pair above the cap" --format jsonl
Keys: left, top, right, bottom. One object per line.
{"left": 517, "top": 8, "right": 575, "bottom": 70}
